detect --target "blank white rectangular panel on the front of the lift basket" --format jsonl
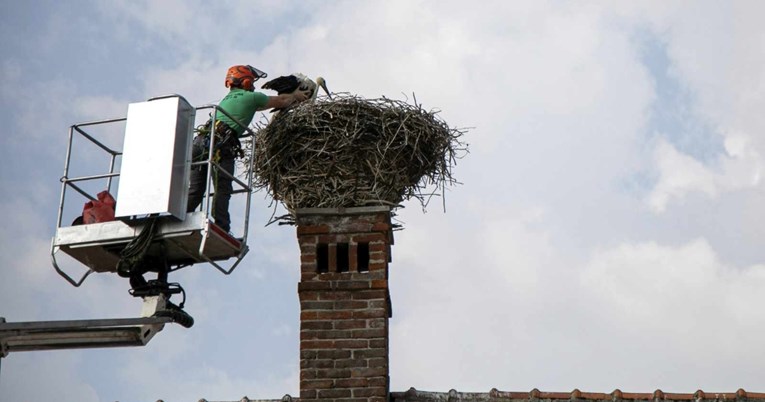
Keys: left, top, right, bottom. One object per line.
{"left": 115, "top": 96, "right": 194, "bottom": 220}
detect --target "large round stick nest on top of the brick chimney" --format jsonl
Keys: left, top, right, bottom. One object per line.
{"left": 248, "top": 94, "right": 467, "bottom": 214}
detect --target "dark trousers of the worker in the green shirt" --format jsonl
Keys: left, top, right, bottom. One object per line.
{"left": 187, "top": 135, "right": 235, "bottom": 232}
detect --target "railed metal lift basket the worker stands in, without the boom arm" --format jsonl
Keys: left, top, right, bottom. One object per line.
{"left": 51, "top": 95, "right": 254, "bottom": 286}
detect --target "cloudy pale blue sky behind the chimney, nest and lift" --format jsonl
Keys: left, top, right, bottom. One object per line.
{"left": 0, "top": 0, "right": 765, "bottom": 402}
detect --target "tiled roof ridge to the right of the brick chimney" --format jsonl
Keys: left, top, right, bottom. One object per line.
{"left": 391, "top": 388, "right": 765, "bottom": 401}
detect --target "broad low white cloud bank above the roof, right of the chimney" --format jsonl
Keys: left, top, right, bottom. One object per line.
{"left": 391, "top": 216, "right": 765, "bottom": 392}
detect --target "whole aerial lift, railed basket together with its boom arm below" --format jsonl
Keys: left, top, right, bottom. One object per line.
{"left": 0, "top": 95, "right": 260, "bottom": 361}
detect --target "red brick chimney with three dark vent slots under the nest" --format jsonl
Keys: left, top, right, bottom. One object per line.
{"left": 296, "top": 207, "right": 393, "bottom": 402}
